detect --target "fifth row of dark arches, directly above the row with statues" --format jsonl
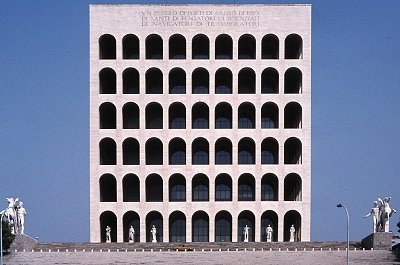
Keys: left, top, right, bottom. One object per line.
{"left": 99, "top": 173, "right": 302, "bottom": 202}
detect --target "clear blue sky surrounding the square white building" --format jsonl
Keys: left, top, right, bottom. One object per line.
{"left": 0, "top": 0, "right": 400, "bottom": 242}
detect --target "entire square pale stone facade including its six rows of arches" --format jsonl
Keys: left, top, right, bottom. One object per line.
{"left": 90, "top": 5, "right": 311, "bottom": 242}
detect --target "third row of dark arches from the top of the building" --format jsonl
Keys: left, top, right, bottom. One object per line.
{"left": 99, "top": 102, "right": 302, "bottom": 129}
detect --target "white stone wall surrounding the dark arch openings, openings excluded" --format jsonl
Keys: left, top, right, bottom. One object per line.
{"left": 90, "top": 5, "right": 311, "bottom": 242}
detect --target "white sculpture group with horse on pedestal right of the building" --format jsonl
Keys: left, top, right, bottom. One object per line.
{"left": 364, "top": 197, "right": 396, "bottom": 233}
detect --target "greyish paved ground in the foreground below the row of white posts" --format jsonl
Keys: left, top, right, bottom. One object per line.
{"left": 4, "top": 250, "right": 400, "bottom": 265}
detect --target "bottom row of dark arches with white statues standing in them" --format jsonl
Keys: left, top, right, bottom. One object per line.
{"left": 99, "top": 210, "right": 301, "bottom": 242}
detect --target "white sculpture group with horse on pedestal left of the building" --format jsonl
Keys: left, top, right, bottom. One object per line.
{"left": 0, "top": 198, "right": 26, "bottom": 235}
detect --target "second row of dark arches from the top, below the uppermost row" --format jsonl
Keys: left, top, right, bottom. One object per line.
{"left": 99, "top": 67, "right": 302, "bottom": 94}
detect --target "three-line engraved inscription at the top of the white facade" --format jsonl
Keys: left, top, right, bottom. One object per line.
{"left": 138, "top": 10, "right": 260, "bottom": 27}
